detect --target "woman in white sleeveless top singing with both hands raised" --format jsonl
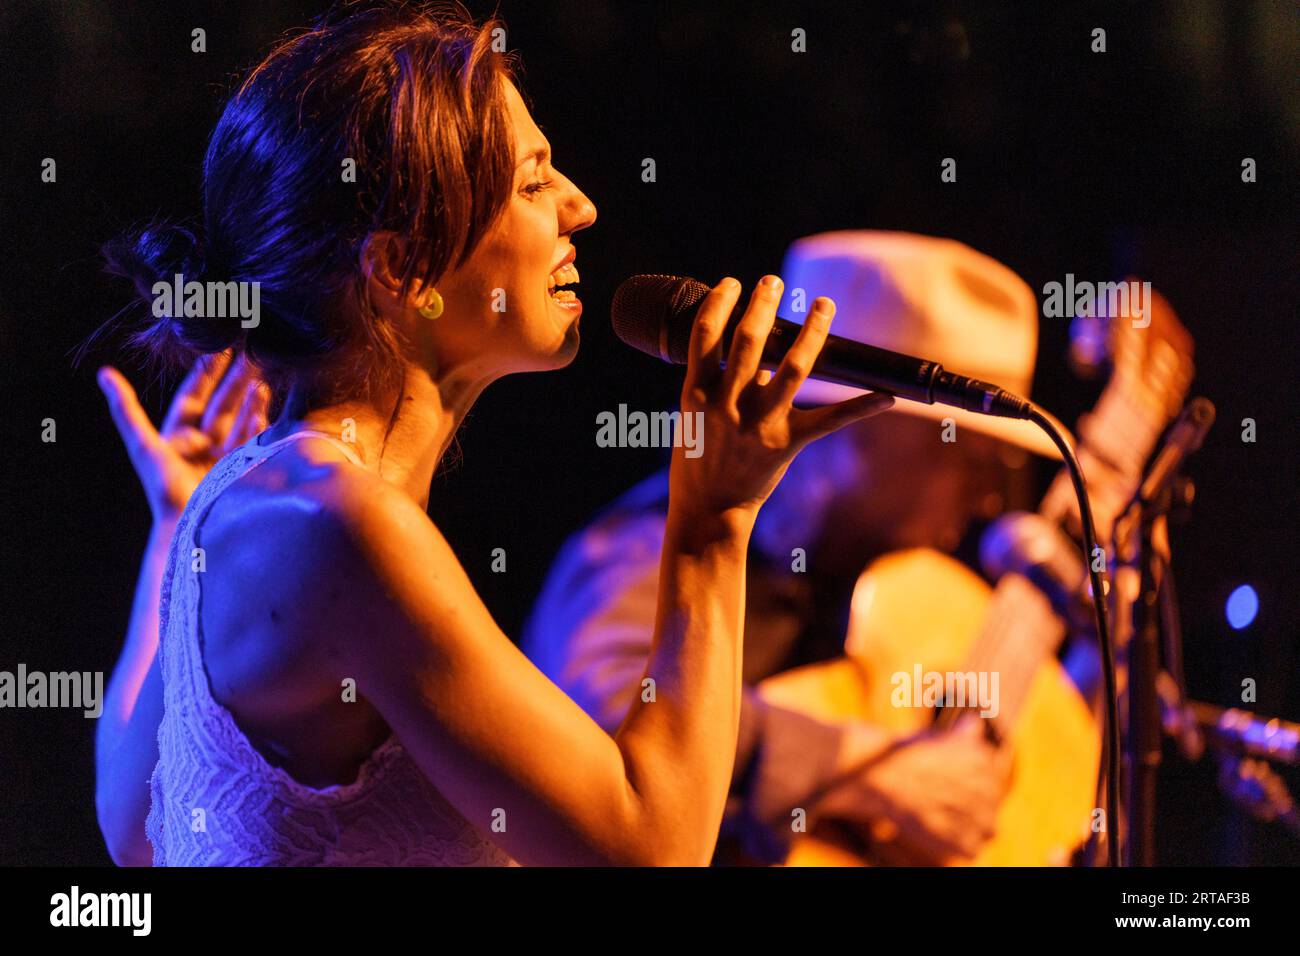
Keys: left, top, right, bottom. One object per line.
{"left": 89, "top": 5, "right": 891, "bottom": 865}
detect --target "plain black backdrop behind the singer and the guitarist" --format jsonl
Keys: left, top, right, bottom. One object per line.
{"left": 0, "top": 0, "right": 1300, "bottom": 864}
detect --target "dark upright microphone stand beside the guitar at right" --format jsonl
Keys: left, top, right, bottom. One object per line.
{"left": 1113, "top": 398, "right": 1214, "bottom": 866}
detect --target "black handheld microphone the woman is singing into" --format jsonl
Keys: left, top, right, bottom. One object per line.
{"left": 610, "top": 276, "right": 1034, "bottom": 419}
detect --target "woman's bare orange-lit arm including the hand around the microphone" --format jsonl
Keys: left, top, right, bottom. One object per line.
{"left": 310, "top": 277, "right": 889, "bottom": 865}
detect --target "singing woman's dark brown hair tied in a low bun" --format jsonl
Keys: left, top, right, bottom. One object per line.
{"left": 104, "top": 1, "right": 515, "bottom": 401}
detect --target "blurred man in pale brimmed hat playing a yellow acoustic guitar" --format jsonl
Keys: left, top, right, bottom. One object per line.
{"left": 524, "top": 232, "right": 1191, "bottom": 865}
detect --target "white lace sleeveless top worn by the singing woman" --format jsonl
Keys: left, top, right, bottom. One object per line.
{"left": 146, "top": 431, "right": 511, "bottom": 866}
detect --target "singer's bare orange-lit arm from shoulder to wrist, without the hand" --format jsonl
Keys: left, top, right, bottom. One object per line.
{"left": 313, "top": 502, "right": 748, "bottom": 865}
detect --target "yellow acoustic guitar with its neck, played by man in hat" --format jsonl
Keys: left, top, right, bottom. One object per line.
{"left": 759, "top": 282, "right": 1193, "bottom": 866}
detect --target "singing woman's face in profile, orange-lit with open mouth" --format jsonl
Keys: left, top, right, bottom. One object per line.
{"left": 429, "top": 83, "right": 595, "bottom": 377}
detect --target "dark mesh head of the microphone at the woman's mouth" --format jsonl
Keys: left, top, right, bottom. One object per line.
{"left": 610, "top": 276, "right": 709, "bottom": 365}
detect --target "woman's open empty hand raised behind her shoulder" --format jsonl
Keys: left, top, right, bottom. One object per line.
{"left": 98, "top": 351, "right": 270, "bottom": 523}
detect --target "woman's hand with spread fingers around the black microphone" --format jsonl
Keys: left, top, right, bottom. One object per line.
{"left": 670, "top": 276, "right": 893, "bottom": 522}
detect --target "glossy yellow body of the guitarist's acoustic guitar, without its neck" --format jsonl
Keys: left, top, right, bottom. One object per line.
{"left": 761, "top": 549, "right": 1101, "bottom": 866}
